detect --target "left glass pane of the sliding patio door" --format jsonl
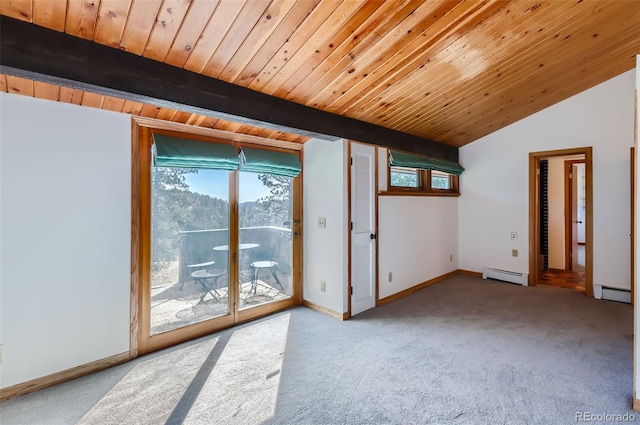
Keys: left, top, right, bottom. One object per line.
{"left": 151, "top": 167, "right": 229, "bottom": 335}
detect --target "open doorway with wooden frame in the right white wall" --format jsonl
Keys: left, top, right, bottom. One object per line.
{"left": 529, "top": 148, "right": 593, "bottom": 296}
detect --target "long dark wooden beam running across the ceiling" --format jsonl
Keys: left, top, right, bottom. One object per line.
{"left": 0, "top": 15, "right": 458, "bottom": 161}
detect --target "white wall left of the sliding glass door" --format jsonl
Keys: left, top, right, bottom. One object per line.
{"left": 0, "top": 93, "right": 131, "bottom": 388}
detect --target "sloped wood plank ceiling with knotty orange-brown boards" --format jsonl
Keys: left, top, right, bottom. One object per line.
{"left": 0, "top": 0, "right": 640, "bottom": 146}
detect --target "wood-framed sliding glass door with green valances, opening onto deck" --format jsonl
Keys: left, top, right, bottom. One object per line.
{"left": 131, "top": 129, "right": 301, "bottom": 357}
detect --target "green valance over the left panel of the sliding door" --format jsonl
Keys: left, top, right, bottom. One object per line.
{"left": 153, "top": 134, "right": 240, "bottom": 170}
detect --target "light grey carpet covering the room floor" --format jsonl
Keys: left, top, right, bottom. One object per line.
{"left": 0, "top": 276, "right": 640, "bottom": 425}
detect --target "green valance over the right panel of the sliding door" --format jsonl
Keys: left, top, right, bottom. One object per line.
{"left": 240, "top": 147, "right": 302, "bottom": 177}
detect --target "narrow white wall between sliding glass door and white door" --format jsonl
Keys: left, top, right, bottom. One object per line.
{"left": 303, "top": 139, "right": 349, "bottom": 313}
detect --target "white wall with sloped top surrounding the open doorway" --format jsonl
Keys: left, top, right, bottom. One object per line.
{"left": 459, "top": 71, "right": 635, "bottom": 289}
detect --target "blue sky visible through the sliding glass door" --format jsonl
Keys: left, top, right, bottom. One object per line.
{"left": 186, "top": 169, "right": 269, "bottom": 202}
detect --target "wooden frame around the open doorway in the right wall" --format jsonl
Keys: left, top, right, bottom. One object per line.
{"left": 529, "top": 146, "right": 593, "bottom": 297}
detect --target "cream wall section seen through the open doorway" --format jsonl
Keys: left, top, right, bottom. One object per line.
{"left": 544, "top": 157, "right": 565, "bottom": 270}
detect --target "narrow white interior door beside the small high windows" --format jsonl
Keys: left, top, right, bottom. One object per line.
{"left": 351, "top": 143, "right": 376, "bottom": 316}
